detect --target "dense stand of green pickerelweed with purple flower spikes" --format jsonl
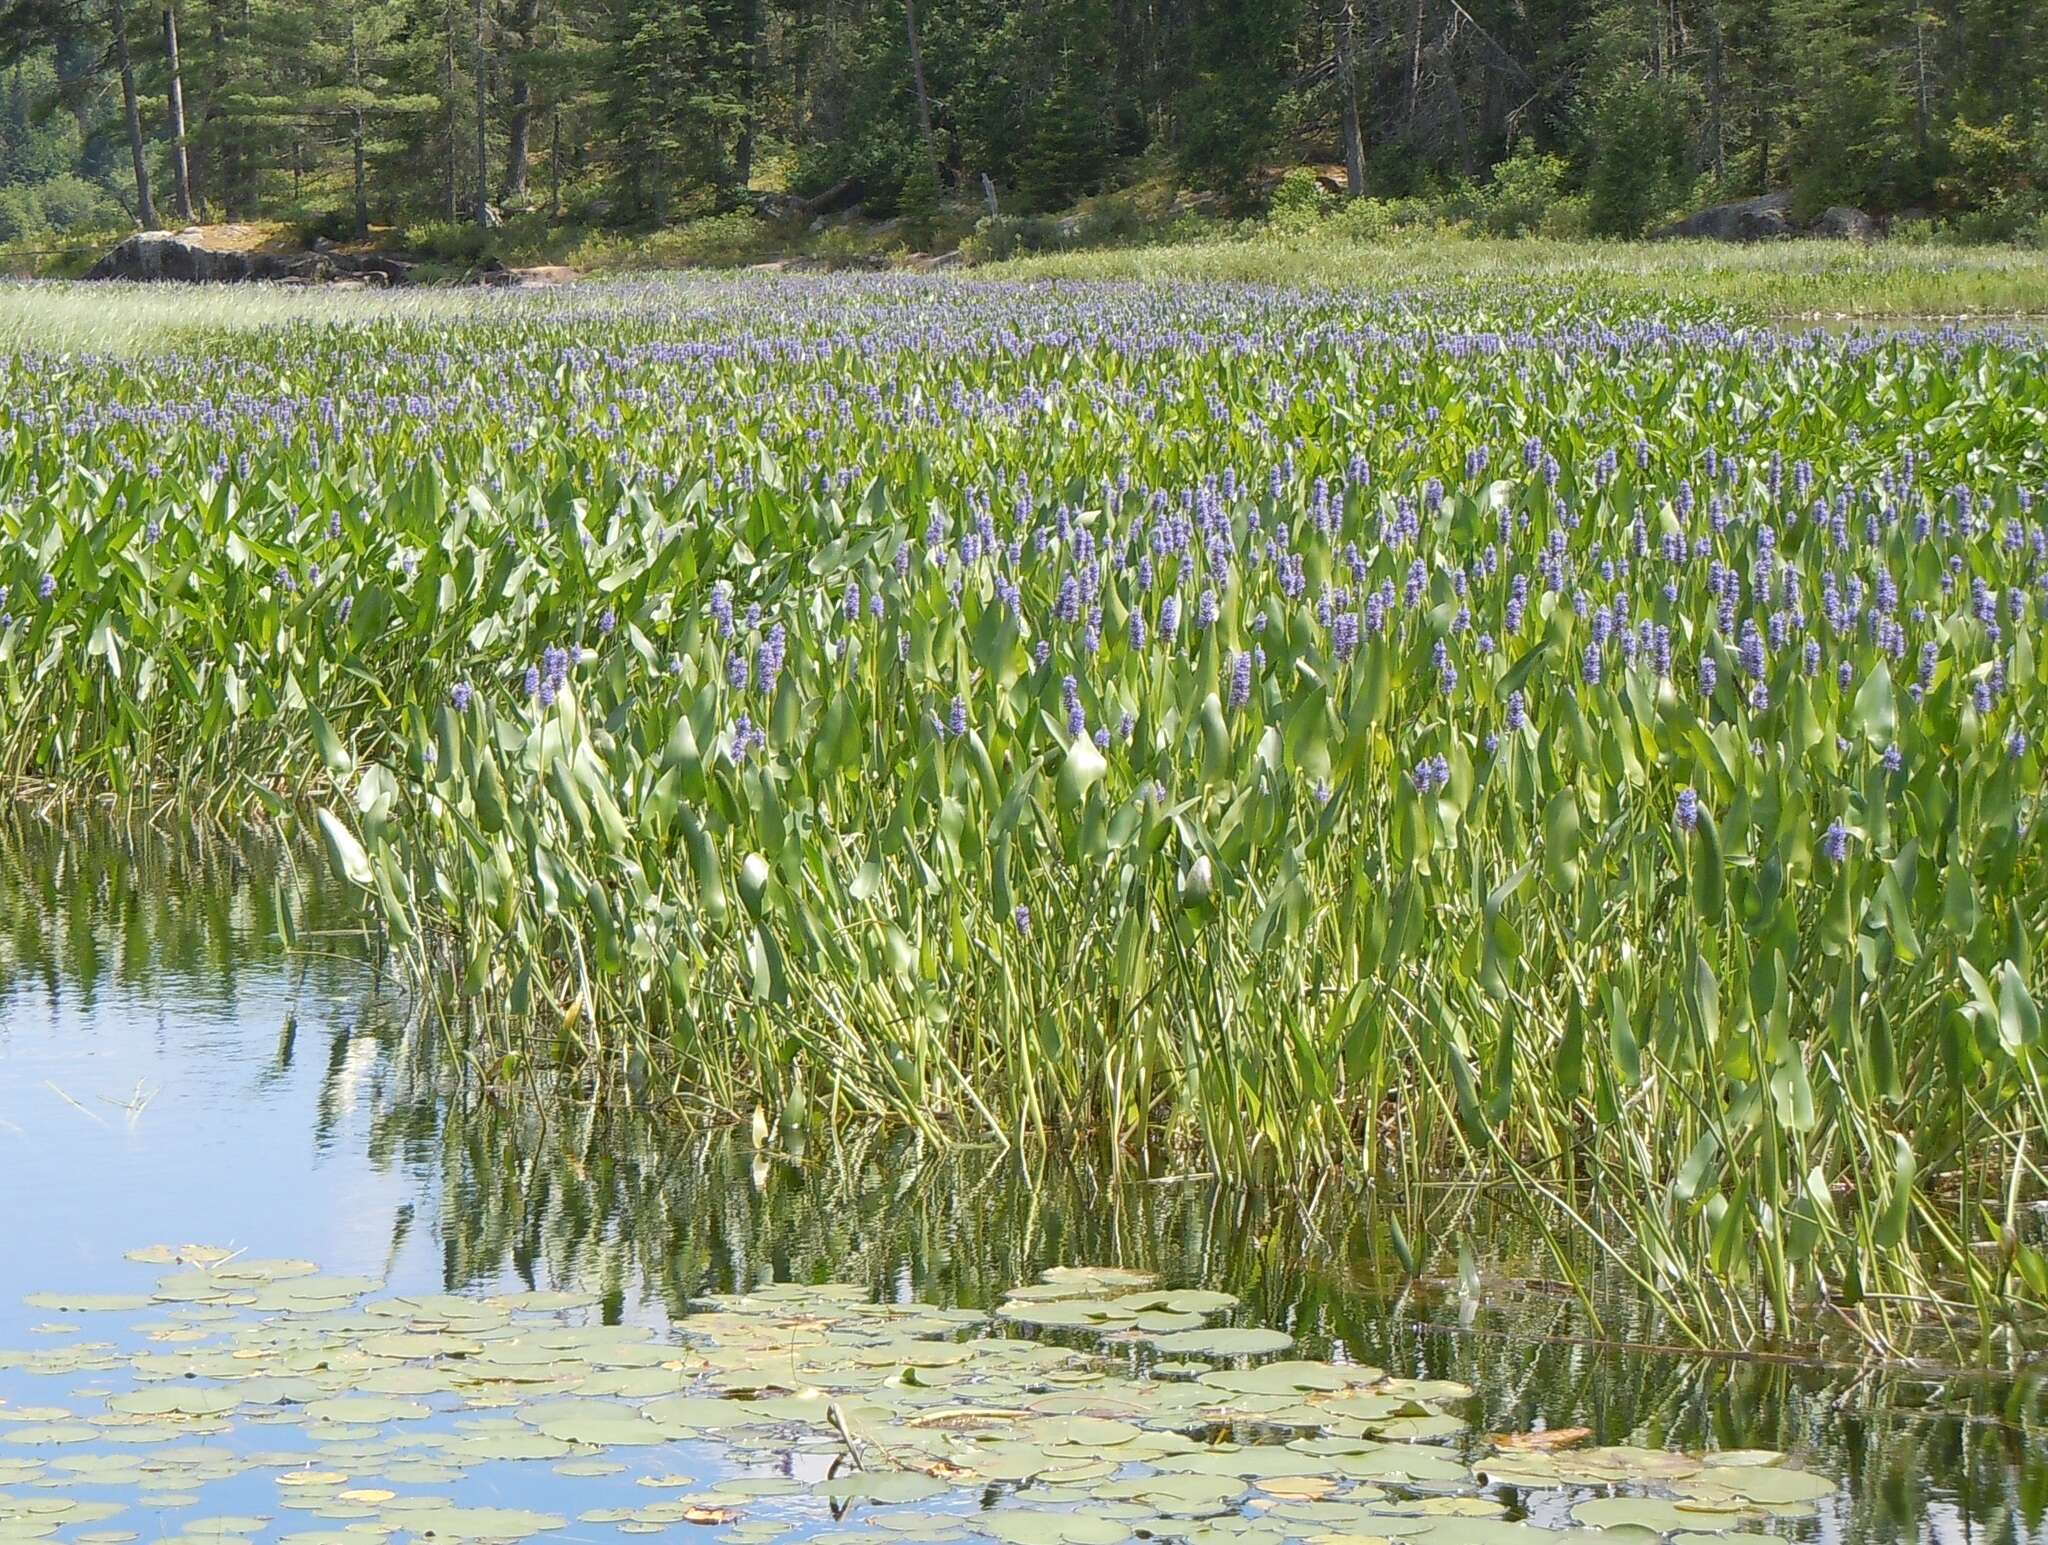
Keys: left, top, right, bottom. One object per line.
{"left": 0, "top": 281, "right": 2048, "bottom": 1340}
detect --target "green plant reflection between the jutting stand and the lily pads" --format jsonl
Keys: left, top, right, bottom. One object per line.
{"left": 399, "top": 1100, "right": 2048, "bottom": 1539}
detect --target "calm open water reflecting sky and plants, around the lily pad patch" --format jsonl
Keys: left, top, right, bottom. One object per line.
{"left": 0, "top": 824, "right": 2048, "bottom": 1545}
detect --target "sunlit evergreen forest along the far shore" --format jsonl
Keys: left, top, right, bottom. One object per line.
{"left": 0, "top": 0, "right": 2048, "bottom": 253}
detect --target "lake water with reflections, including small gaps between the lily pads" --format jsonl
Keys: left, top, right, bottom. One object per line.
{"left": 0, "top": 822, "right": 2048, "bottom": 1545}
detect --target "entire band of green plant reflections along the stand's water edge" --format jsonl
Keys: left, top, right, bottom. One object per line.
{"left": 0, "top": 820, "right": 2048, "bottom": 1541}
